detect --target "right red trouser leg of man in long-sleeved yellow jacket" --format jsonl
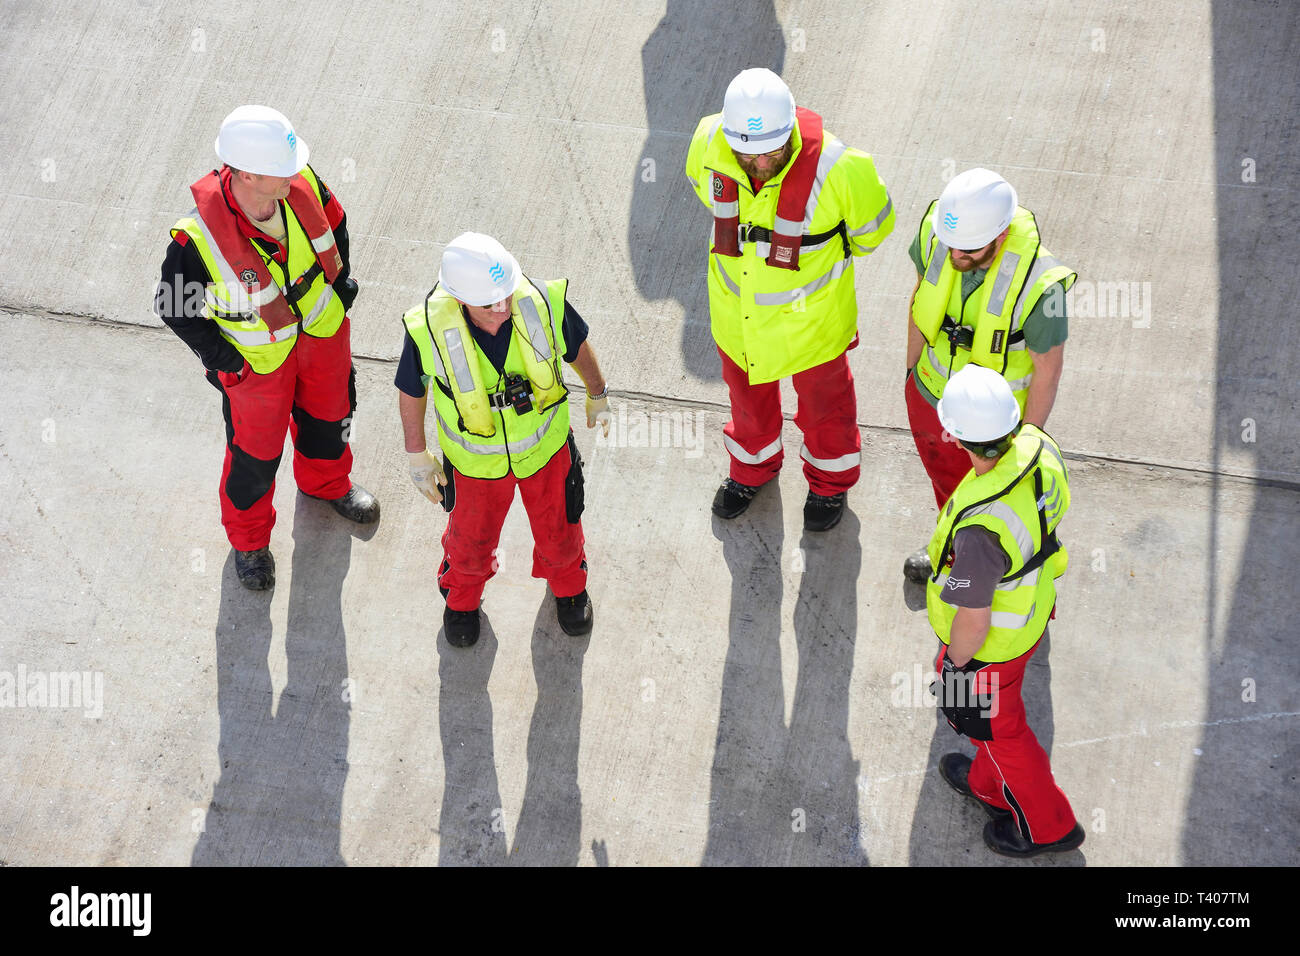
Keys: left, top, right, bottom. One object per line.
{"left": 793, "top": 354, "right": 862, "bottom": 496}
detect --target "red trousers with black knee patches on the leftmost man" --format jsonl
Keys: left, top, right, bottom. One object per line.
{"left": 209, "top": 317, "right": 356, "bottom": 551}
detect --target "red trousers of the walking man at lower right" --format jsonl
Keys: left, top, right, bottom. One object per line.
{"left": 936, "top": 634, "right": 1075, "bottom": 843}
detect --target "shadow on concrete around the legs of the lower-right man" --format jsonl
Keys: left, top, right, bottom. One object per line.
{"left": 907, "top": 629, "right": 1089, "bottom": 866}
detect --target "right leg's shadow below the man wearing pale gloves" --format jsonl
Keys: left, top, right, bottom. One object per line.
{"left": 510, "top": 592, "right": 592, "bottom": 866}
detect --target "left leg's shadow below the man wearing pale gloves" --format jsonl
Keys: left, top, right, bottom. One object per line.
{"left": 438, "top": 611, "right": 507, "bottom": 866}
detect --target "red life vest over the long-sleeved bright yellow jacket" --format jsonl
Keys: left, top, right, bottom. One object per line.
{"left": 712, "top": 107, "right": 822, "bottom": 269}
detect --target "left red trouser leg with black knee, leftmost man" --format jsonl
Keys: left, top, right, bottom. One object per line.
{"left": 218, "top": 352, "right": 294, "bottom": 551}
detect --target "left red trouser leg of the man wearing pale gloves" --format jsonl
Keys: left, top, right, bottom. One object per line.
{"left": 438, "top": 472, "right": 515, "bottom": 611}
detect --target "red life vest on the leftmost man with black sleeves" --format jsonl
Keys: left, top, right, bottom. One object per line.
{"left": 190, "top": 169, "right": 343, "bottom": 332}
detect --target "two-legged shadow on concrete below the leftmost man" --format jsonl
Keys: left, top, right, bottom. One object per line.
{"left": 191, "top": 494, "right": 356, "bottom": 866}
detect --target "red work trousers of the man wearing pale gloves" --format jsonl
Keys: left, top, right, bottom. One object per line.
{"left": 438, "top": 445, "right": 586, "bottom": 611}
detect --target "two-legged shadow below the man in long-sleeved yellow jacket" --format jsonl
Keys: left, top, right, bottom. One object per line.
{"left": 702, "top": 502, "right": 867, "bottom": 866}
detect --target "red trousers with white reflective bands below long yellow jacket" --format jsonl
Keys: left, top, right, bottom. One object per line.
{"left": 718, "top": 349, "right": 862, "bottom": 496}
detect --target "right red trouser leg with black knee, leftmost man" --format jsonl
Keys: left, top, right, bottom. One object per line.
{"left": 286, "top": 317, "right": 356, "bottom": 499}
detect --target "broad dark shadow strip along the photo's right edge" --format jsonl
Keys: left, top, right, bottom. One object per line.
{"left": 1190, "top": 0, "right": 1300, "bottom": 866}
